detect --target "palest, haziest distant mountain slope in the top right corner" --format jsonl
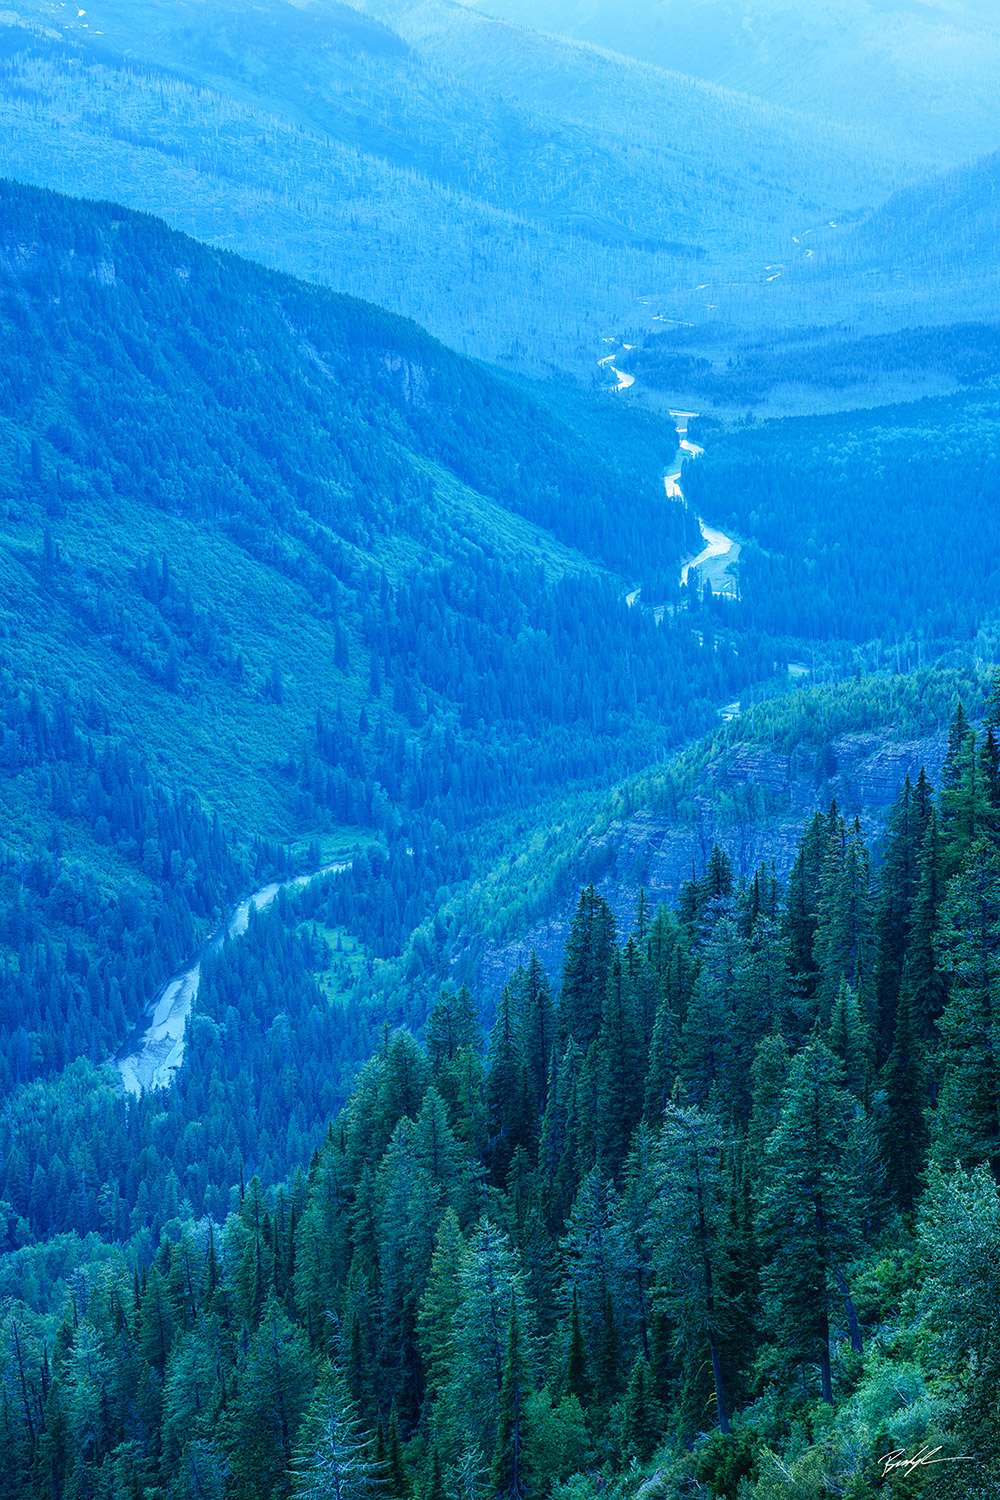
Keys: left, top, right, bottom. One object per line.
{"left": 465, "top": 0, "right": 1000, "bottom": 161}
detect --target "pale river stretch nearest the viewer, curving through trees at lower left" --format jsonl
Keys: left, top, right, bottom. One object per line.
{"left": 115, "top": 863, "right": 348, "bottom": 1097}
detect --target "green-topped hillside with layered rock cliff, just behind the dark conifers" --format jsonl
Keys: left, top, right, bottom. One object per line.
{"left": 470, "top": 665, "right": 990, "bottom": 1002}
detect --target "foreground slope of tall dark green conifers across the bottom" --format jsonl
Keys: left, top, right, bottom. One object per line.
{"left": 0, "top": 680, "right": 1000, "bottom": 1500}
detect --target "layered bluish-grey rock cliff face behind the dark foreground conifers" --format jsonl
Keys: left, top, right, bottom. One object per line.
{"left": 478, "top": 731, "right": 948, "bottom": 1005}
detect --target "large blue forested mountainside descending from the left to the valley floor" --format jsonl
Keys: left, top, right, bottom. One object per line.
{"left": 0, "top": 183, "right": 774, "bottom": 1233}
